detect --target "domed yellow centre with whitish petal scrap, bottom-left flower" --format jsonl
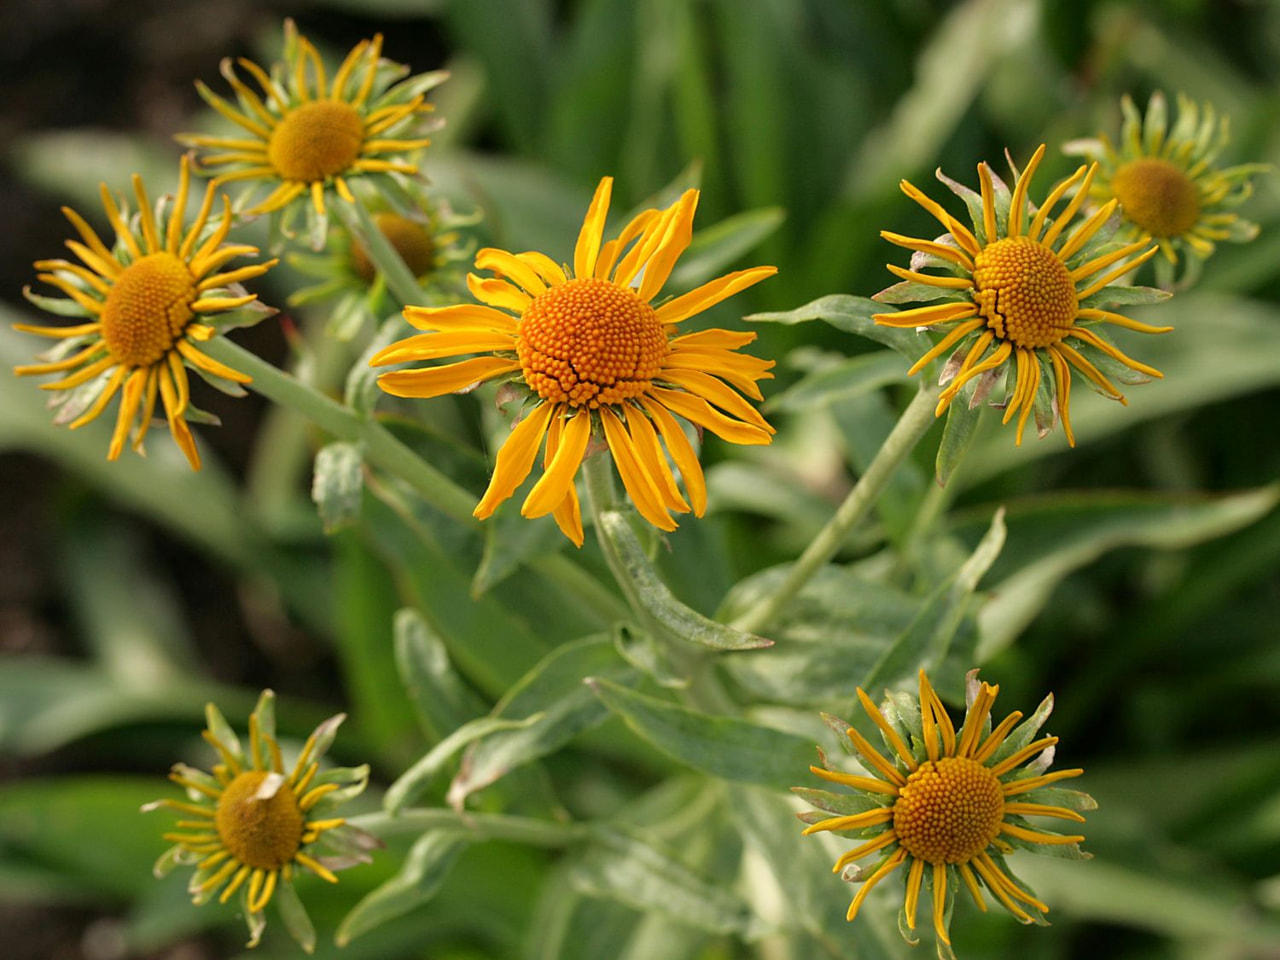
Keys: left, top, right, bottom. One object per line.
{"left": 215, "top": 771, "right": 306, "bottom": 870}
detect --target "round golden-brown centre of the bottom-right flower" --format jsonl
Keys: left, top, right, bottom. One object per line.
{"left": 893, "top": 756, "right": 1005, "bottom": 863}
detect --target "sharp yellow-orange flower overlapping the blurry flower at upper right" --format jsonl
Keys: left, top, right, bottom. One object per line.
{"left": 873, "top": 145, "right": 1172, "bottom": 447}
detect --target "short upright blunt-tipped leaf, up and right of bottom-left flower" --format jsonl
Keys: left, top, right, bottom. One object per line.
{"left": 394, "top": 607, "right": 485, "bottom": 741}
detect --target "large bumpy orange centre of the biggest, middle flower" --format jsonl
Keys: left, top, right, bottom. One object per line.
{"left": 516, "top": 279, "right": 671, "bottom": 408}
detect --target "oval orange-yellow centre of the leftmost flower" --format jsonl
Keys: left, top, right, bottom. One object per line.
{"left": 101, "top": 252, "right": 196, "bottom": 367}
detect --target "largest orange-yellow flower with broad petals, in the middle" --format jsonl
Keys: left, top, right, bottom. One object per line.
{"left": 371, "top": 177, "right": 777, "bottom": 545}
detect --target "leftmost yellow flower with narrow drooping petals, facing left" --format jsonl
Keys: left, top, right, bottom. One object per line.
{"left": 14, "top": 157, "right": 276, "bottom": 470}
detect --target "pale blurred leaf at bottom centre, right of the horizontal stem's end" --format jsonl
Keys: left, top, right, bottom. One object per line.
{"left": 570, "top": 827, "right": 754, "bottom": 938}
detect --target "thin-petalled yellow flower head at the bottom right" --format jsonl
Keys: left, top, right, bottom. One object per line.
{"left": 795, "top": 671, "right": 1097, "bottom": 957}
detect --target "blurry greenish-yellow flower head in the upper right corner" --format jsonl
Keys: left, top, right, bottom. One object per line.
{"left": 1064, "top": 91, "right": 1270, "bottom": 287}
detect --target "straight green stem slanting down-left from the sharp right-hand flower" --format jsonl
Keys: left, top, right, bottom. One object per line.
{"left": 732, "top": 381, "right": 940, "bottom": 634}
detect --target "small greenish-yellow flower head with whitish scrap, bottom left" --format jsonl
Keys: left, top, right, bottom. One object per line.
{"left": 142, "top": 690, "right": 380, "bottom": 951}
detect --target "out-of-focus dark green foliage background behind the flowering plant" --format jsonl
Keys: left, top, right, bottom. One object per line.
{"left": 0, "top": 0, "right": 1280, "bottom": 960}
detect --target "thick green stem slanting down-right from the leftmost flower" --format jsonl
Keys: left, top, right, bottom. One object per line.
{"left": 201, "top": 337, "right": 479, "bottom": 526}
